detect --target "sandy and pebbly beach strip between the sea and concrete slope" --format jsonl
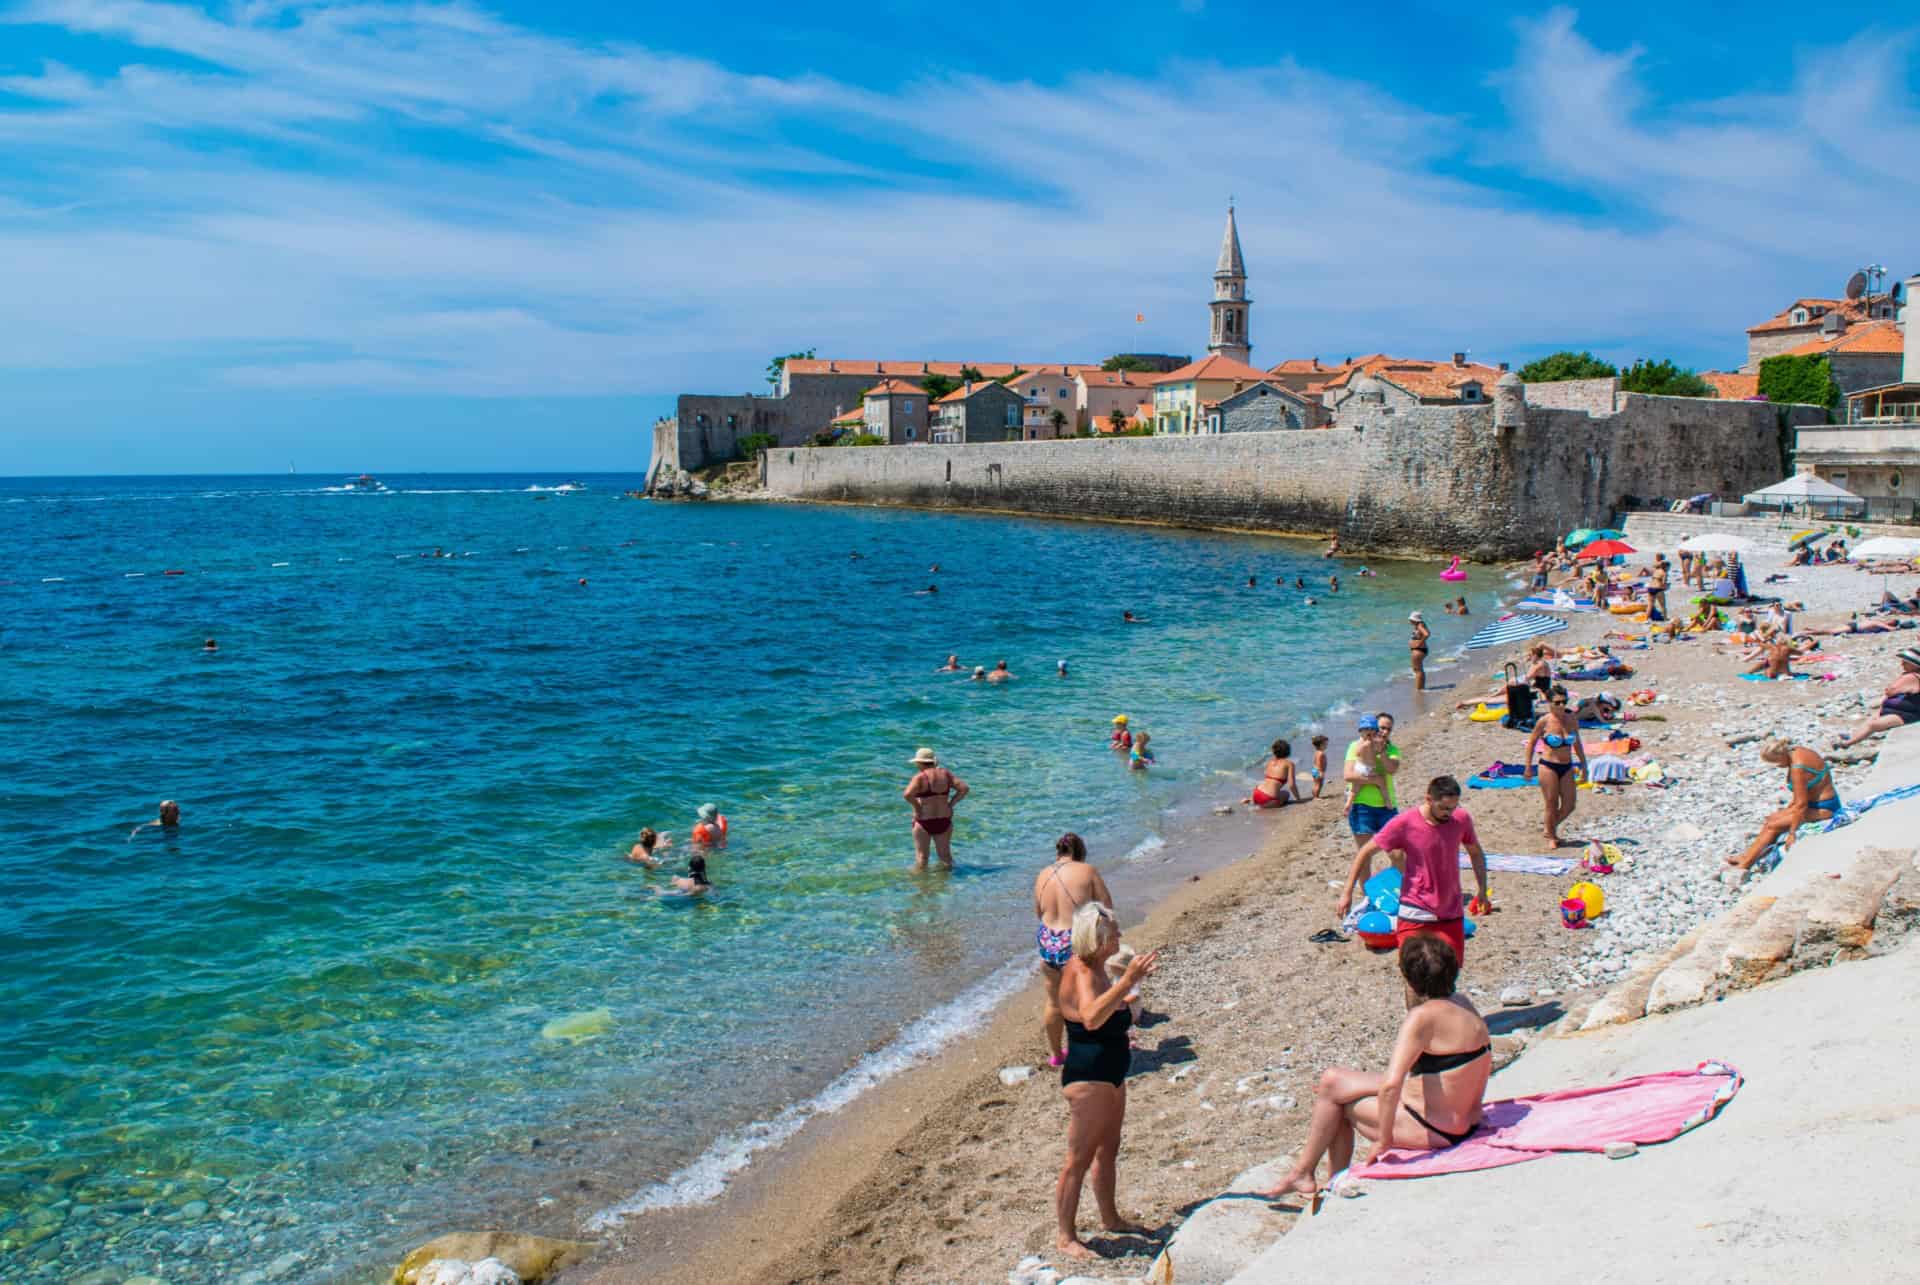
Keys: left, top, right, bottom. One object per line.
{"left": 568, "top": 555, "right": 1920, "bottom": 1285}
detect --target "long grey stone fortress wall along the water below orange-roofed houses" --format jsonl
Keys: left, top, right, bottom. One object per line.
{"left": 762, "top": 380, "right": 1824, "bottom": 561}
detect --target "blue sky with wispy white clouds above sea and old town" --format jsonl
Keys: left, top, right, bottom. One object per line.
{"left": 0, "top": 0, "right": 1920, "bottom": 474}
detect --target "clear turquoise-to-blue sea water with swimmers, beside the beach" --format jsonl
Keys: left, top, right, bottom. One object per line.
{"left": 0, "top": 476, "right": 1492, "bottom": 1281}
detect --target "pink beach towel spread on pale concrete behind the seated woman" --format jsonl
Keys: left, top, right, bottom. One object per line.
{"left": 1352, "top": 1062, "right": 1741, "bottom": 1177}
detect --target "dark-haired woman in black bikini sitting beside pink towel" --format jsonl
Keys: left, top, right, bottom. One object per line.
{"left": 1260, "top": 933, "right": 1494, "bottom": 1212}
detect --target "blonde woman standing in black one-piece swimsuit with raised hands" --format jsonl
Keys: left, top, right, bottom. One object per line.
{"left": 1054, "top": 901, "right": 1160, "bottom": 1258}
